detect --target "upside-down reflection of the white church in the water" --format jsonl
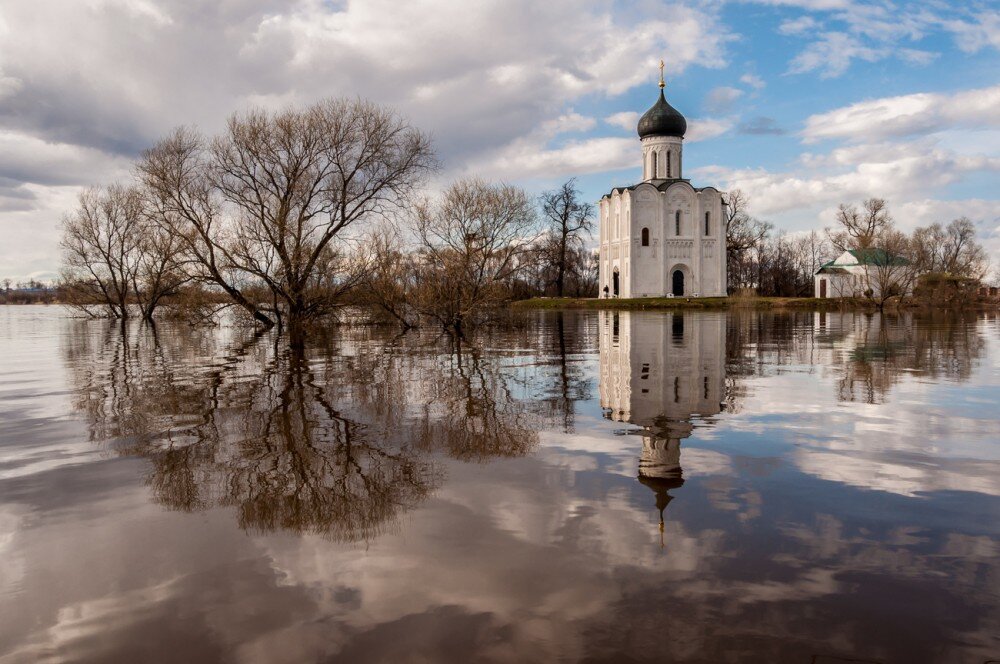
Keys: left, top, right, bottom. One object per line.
{"left": 599, "top": 311, "right": 726, "bottom": 542}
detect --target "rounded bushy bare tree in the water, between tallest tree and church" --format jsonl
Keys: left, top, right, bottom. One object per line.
{"left": 415, "top": 179, "right": 535, "bottom": 334}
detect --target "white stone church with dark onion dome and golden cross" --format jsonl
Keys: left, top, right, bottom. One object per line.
{"left": 599, "top": 72, "right": 726, "bottom": 297}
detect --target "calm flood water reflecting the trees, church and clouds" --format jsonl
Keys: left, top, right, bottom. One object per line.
{"left": 0, "top": 307, "right": 1000, "bottom": 663}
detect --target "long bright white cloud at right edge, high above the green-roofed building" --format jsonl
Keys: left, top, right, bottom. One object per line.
{"left": 802, "top": 85, "right": 1000, "bottom": 142}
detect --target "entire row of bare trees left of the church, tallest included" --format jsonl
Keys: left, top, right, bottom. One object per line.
{"left": 62, "top": 99, "right": 596, "bottom": 335}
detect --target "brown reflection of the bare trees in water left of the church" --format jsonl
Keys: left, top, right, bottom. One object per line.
{"left": 65, "top": 325, "right": 538, "bottom": 541}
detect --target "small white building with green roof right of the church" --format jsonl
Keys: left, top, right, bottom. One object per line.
{"left": 813, "top": 249, "right": 912, "bottom": 298}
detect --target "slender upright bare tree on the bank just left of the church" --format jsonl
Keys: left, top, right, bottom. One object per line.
{"left": 540, "top": 179, "right": 594, "bottom": 297}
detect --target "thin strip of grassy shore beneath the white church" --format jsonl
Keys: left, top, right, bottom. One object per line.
{"left": 512, "top": 297, "right": 872, "bottom": 310}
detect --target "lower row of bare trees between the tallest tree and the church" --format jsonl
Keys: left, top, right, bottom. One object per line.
{"left": 361, "top": 179, "right": 597, "bottom": 333}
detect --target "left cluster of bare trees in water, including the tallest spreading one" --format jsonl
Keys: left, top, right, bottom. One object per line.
{"left": 63, "top": 100, "right": 436, "bottom": 332}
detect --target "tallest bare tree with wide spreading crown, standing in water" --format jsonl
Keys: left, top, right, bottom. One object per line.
{"left": 139, "top": 100, "right": 436, "bottom": 336}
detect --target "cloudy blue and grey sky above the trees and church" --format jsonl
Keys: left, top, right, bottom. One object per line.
{"left": 0, "top": 0, "right": 1000, "bottom": 280}
